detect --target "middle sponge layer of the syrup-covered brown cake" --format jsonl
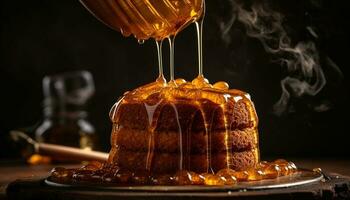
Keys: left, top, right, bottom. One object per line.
{"left": 112, "top": 128, "right": 258, "bottom": 154}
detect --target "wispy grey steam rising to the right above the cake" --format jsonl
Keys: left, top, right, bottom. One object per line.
{"left": 220, "top": 0, "right": 341, "bottom": 115}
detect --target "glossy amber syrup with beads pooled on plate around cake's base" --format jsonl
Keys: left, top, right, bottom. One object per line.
{"left": 51, "top": 159, "right": 298, "bottom": 186}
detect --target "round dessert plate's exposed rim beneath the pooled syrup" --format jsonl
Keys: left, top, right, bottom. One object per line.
{"left": 45, "top": 169, "right": 326, "bottom": 192}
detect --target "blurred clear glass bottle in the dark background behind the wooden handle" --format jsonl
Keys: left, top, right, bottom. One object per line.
{"left": 35, "top": 71, "right": 97, "bottom": 150}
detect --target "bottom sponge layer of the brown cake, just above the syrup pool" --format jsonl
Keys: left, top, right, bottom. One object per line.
{"left": 109, "top": 150, "right": 258, "bottom": 174}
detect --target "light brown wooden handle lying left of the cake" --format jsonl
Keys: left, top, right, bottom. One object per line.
{"left": 36, "top": 143, "right": 108, "bottom": 162}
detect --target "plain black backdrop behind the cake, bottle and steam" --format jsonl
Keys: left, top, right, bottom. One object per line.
{"left": 0, "top": 0, "right": 350, "bottom": 157}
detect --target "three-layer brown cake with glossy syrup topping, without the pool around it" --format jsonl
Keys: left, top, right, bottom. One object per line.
{"left": 108, "top": 77, "right": 259, "bottom": 175}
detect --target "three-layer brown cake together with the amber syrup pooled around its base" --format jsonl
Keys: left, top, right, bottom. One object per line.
{"left": 50, "top": 77, "right": 297, "bottom": 186}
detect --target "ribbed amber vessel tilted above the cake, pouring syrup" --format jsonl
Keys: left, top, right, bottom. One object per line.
{"left": 80, "top": 0, "right": 204, "bottom": 40}
